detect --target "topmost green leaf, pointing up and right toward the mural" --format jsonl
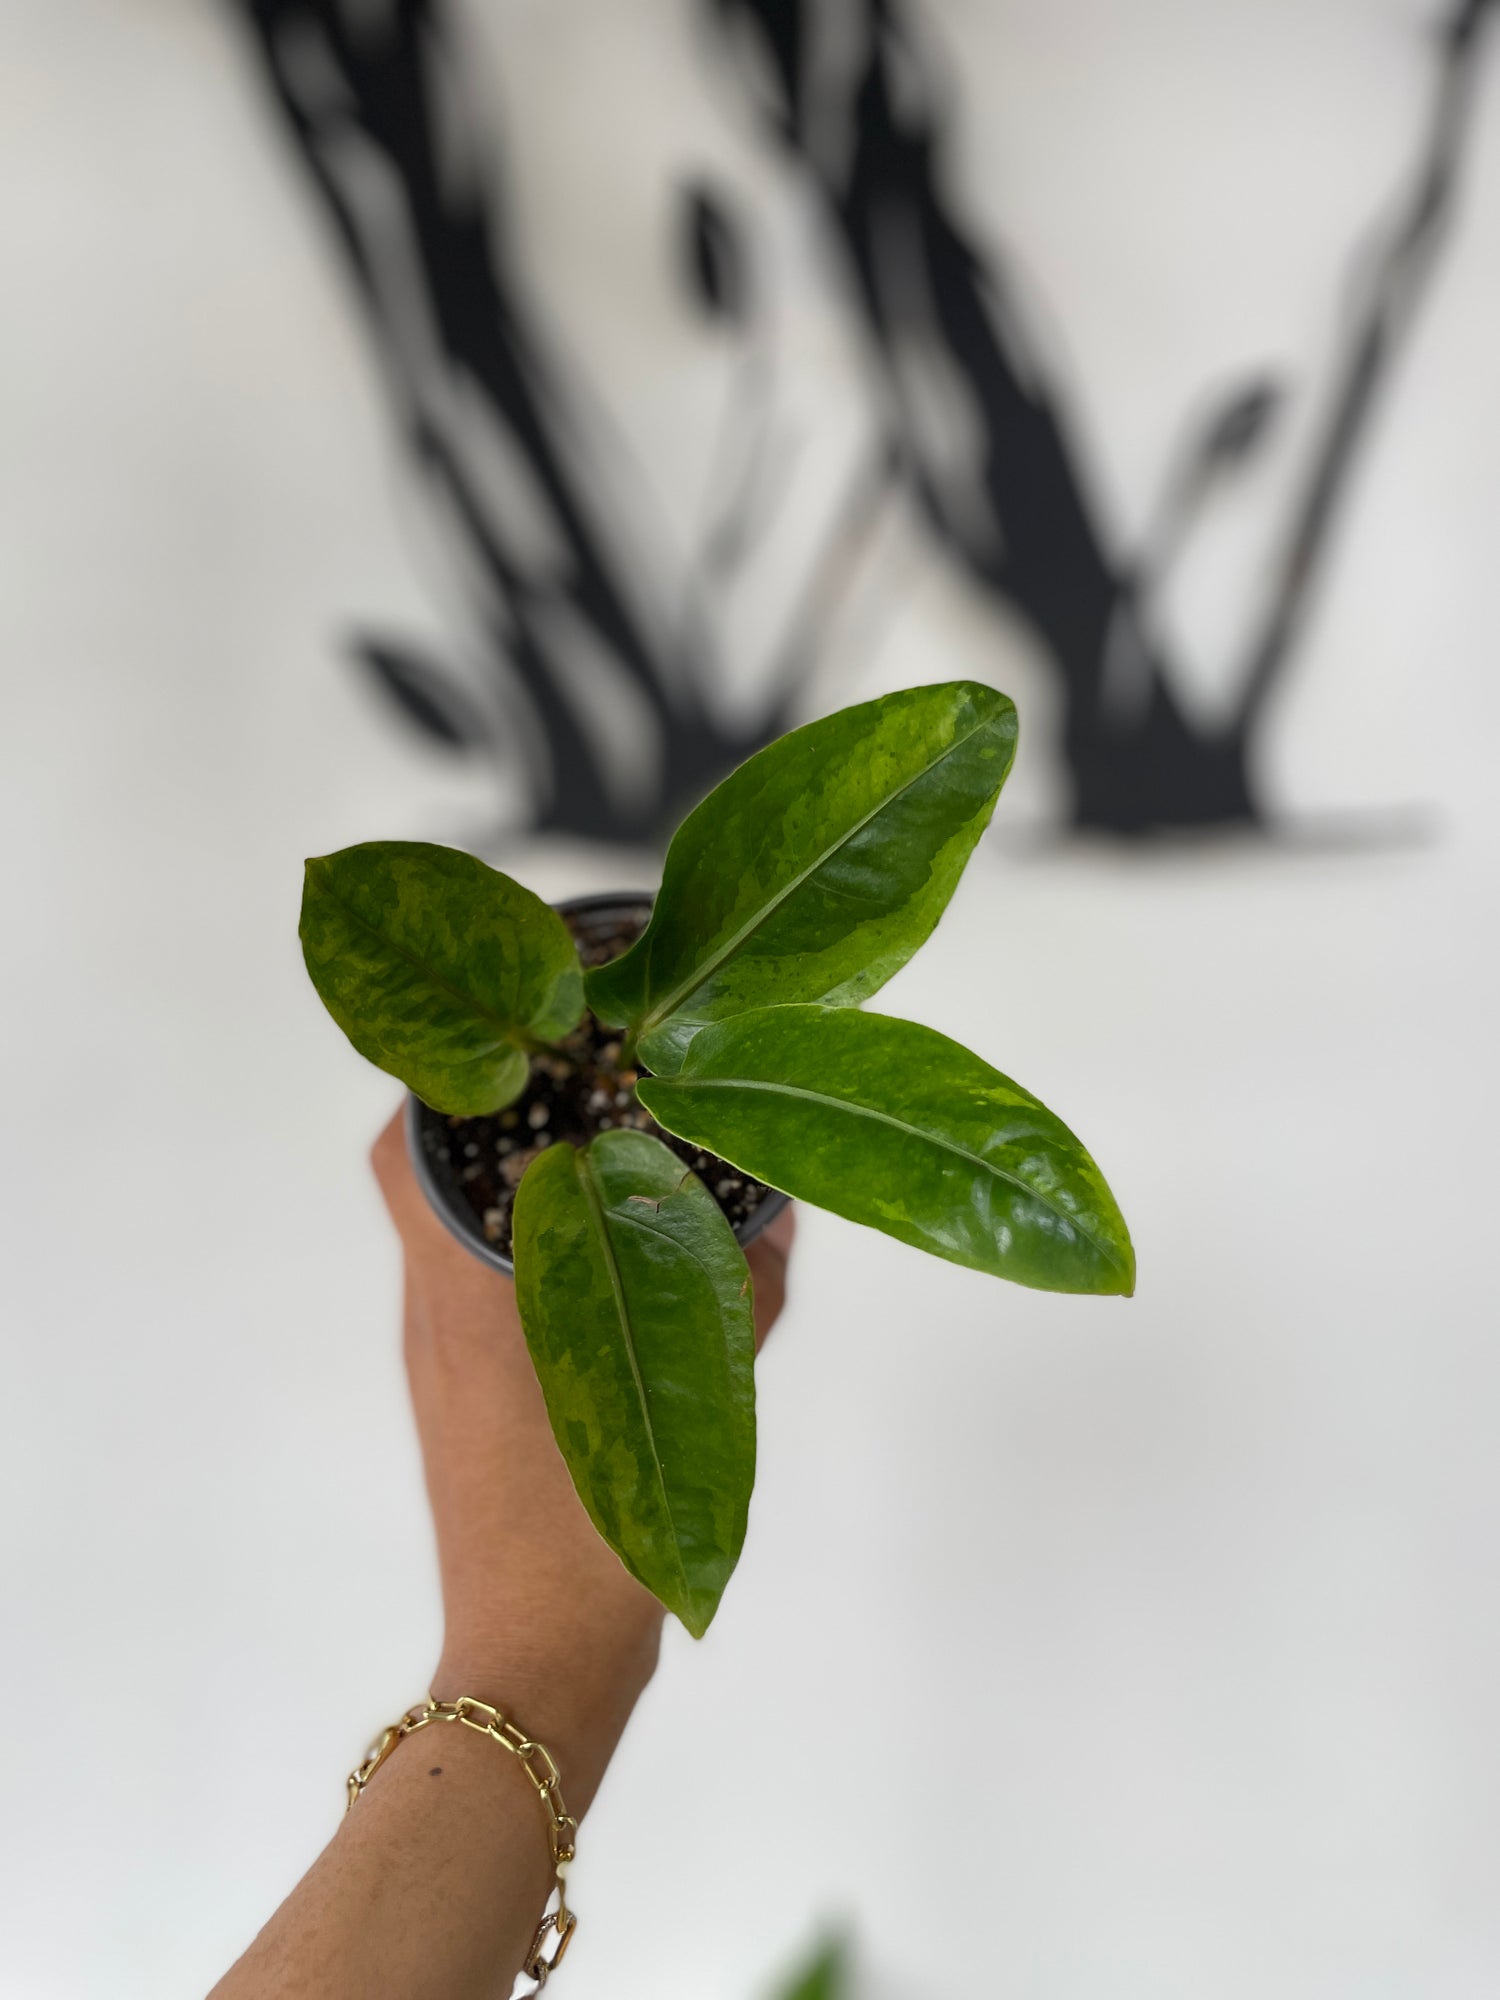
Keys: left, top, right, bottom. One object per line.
{"left": 586, "top": 680, "right": 1016, "bottom": 1076}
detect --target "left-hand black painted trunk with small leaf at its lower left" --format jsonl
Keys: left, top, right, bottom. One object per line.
{"left": 236, "top": 0, "right": 800, "bottom": 842}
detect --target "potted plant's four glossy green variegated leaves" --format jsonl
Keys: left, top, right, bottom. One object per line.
{"left": 302, "top": 682, "right": 1136, "bottom": 1634}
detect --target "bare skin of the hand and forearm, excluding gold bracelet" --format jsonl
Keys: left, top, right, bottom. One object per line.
{"left": 210, "top": 1118, "right": 792, "bottom": 2000}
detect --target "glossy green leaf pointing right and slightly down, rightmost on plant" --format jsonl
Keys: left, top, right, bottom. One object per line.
{"left": 636, "top": 1006, "right": 1136, "bottom": 1292}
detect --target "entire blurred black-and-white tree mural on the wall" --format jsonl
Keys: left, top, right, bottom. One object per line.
{"left": 238, "top": 0, "right": 1494, "bottom": 844}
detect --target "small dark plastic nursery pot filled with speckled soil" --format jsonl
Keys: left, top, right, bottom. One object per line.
{"left": 406, "top": 892, "right": 788, "bottom": 1276}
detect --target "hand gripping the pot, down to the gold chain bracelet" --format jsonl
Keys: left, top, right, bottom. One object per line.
{"left": 372, "top": 1112, "right": 794, "bottom": 1812}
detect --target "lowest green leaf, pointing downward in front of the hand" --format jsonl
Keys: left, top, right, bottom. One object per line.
{"left": 516, "top": 1132, "right": 756, "bottom": 1638}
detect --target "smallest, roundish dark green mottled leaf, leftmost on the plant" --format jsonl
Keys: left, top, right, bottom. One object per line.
{"left": 300, "top": 840, "right": 584, "bottom": 1118}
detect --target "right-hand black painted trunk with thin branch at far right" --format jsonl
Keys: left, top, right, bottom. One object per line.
{"left": 704, "top": 0, "right": 1496, "bottom": 834}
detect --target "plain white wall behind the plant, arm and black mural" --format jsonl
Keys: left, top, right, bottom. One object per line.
{"left": 0, "top": 0, "right": 1500, "bottom": 2000}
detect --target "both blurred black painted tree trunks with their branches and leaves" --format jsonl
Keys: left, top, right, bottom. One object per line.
{"left": 236, "top": 0, "right": 1498, "bottom": 840}
